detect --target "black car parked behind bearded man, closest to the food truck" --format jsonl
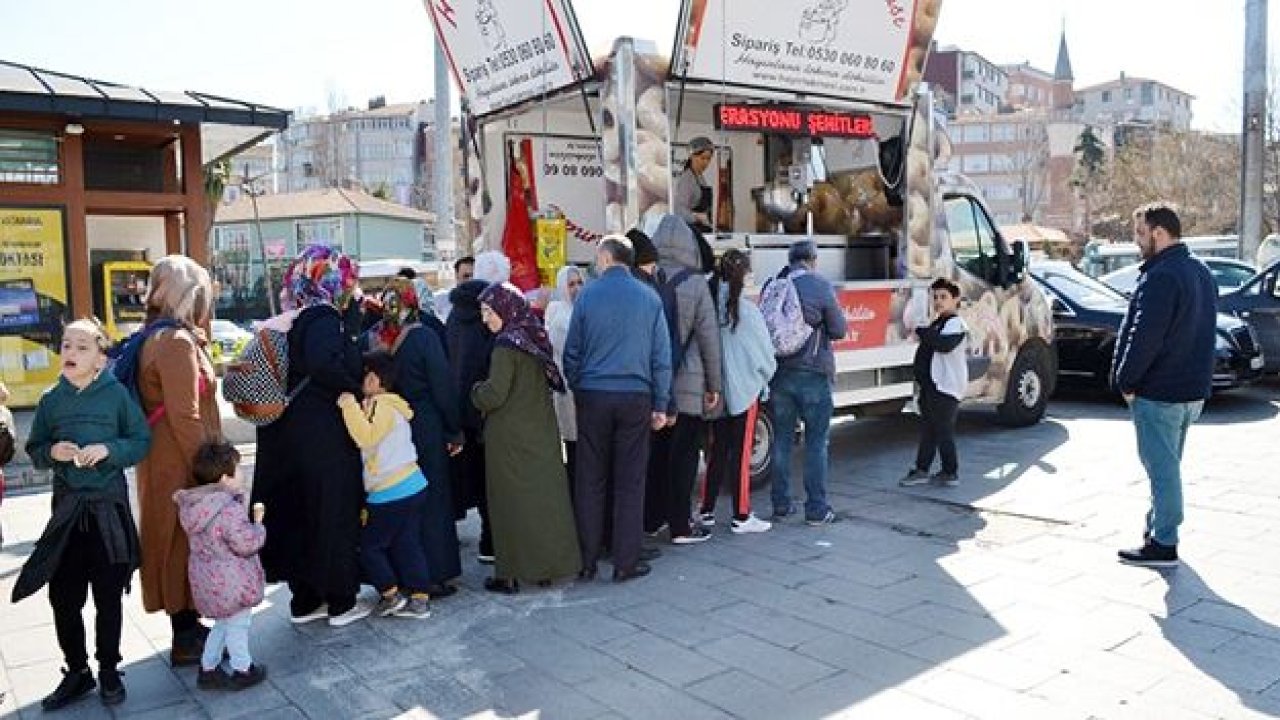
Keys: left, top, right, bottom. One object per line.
{"left": 1030, "top": 261, "right": 1259, "bottom": 391}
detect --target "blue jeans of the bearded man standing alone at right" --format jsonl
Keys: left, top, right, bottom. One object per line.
{"left": 1132, "top": 397, "right": 1204, "bottom": 544}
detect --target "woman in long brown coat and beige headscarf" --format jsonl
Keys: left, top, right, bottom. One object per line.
{"left": 138, "top": 255, "right": 221, "bottom": 666}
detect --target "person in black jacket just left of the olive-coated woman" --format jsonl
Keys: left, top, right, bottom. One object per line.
{"left": 444, "top": 281, "right": 493, "bottom": 564}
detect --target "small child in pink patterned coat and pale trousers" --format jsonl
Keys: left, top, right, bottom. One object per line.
{"left": 173, "top": 442, "right": 266, "bottom": 691}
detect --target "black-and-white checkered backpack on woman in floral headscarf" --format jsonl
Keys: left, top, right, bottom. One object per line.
{"left": 223, "top": 320, "right": 311, "bottom": 428}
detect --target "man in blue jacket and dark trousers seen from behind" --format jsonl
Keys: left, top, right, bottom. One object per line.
{"left": 563, "top": 234, "right": 671, "bottom": 582}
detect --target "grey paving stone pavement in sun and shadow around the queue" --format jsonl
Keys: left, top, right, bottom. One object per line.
{"left": 0, "top": 383, "right": 1280, "bottom": 720}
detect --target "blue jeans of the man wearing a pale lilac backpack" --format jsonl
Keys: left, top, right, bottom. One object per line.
{"left": 769, "top": 370, "right": 832, "bottom": 520}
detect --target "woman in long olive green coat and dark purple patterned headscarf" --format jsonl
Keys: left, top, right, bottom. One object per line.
{"left": 471, "top": 283, "right": 582, "bottom": 593}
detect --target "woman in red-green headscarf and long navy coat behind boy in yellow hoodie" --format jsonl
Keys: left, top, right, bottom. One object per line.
{"left": 364, "top": 278, "right": 462, "bottom": 591}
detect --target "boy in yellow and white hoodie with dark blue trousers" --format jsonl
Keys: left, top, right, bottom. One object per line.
{"left": 338, "top": 352, "right": 431, "bottom": 619}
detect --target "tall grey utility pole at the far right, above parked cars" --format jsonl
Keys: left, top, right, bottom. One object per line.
{"left": 1240, "top": 0, "right": 1267, "bottom": 261}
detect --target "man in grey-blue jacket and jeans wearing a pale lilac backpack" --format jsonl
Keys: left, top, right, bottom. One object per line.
{"left": 769, "top": 240, "right": 849, "bottom": 525}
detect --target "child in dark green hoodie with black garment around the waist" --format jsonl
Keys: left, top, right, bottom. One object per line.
{"left": 13, "top": 319, "right": 151, "bottom": 711}
